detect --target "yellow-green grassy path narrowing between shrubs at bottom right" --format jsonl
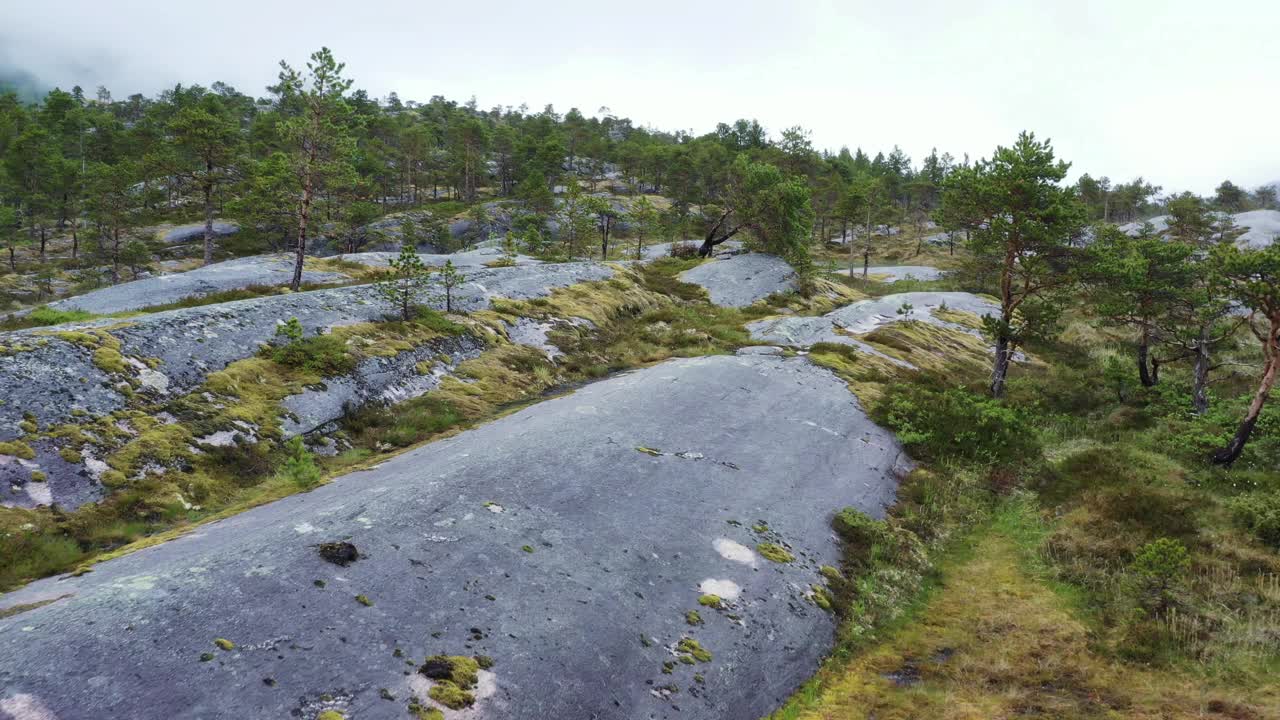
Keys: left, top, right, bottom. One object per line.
{"left": 777, "top": 502, "right": 1280, "bottom": 720}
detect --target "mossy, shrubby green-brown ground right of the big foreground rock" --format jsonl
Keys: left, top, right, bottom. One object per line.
{"left": 773, "top": 295, "right": 1280, "bottom": 719}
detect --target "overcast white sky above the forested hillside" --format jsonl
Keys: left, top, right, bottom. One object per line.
{"left": 0, "top": 0, "right": 1280, "bottom": 192}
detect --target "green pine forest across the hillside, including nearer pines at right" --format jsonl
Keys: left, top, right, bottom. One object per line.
{"left": 0, "top": 49, "right": 1280, "bottom": 464}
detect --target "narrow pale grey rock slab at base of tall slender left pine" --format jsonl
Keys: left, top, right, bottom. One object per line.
{"left": 49, "top": 254, "right": 347, "bottom": 315}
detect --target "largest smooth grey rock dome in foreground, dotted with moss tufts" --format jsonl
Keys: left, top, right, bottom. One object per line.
{"left": 0, "top": 356, "right": 904, "bottom": 720}
